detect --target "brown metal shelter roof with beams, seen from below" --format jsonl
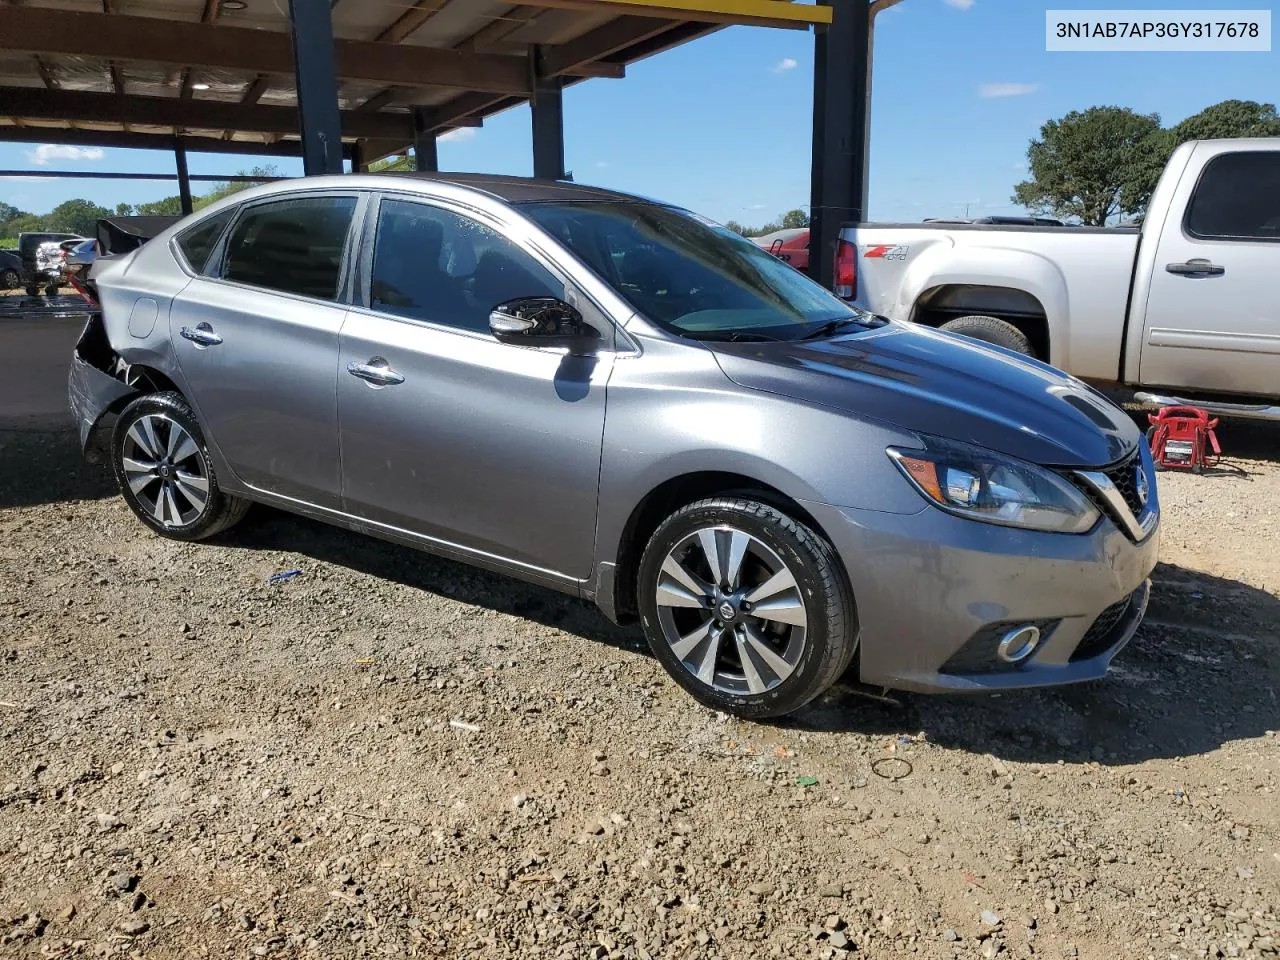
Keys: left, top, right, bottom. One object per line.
{"left": 0, "top": 0, "right": 831, "bottom": 159}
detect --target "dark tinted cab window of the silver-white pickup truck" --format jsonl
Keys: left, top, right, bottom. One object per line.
{"left": 1185, "top": 152, "right": 1280, "bottom": 241}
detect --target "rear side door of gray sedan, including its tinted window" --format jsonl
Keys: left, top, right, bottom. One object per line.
{"left": 170, "top": 191, "right": 364, "bottom": 508}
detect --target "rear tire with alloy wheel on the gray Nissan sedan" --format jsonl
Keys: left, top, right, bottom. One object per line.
{"left": 111, "top": 392, "right": 250, "bottom": 540}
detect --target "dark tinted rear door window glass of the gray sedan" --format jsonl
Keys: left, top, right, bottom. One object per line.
{"left": 223, "top": 197, "right": 356, "bottom": 300}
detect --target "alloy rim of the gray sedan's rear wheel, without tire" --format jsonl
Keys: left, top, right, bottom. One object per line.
{"left": 120, "top": 413, "right": 209, "bottom": 527}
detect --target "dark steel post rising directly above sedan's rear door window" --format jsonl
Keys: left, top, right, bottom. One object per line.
{"left": 289, "top": 0, "right": 342, "bottom": 177}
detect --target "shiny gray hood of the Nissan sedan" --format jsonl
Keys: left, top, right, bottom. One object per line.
{"left": 705, "top": 323, "right": 1142, "bottom": 467}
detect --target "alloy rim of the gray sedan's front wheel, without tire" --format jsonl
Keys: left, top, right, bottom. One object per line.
{"left": 655, "top": 525, "right": 809, "bottom": 696}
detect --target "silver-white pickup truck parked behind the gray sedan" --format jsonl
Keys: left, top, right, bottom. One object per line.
{"left": 836, "top": 138, "right": 1280, "bottom": 420}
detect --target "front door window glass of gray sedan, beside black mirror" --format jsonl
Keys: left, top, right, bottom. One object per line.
{"left": 370, "top": 200, "right": 564, "bottom": 332}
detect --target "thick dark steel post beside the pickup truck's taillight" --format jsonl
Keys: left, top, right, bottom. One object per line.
{"left": 809, "top": 0, "right": 872, "bottom": 289}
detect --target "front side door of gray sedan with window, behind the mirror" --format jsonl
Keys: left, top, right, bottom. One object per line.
{"left": 338, "top": 198, "right": 613, "bottom": 580}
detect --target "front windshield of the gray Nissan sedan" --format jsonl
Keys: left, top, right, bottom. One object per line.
{"left": 524, "top": 201, "right": 873, "bottom": 339}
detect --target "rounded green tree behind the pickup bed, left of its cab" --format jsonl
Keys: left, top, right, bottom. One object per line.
{"left": 1012, "top": 106, "right": 1162, "bottom": 227}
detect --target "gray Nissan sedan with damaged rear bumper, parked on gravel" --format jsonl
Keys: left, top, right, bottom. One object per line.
{"left": 70, "top": 174, "right": 1160, "bottom": 717}
